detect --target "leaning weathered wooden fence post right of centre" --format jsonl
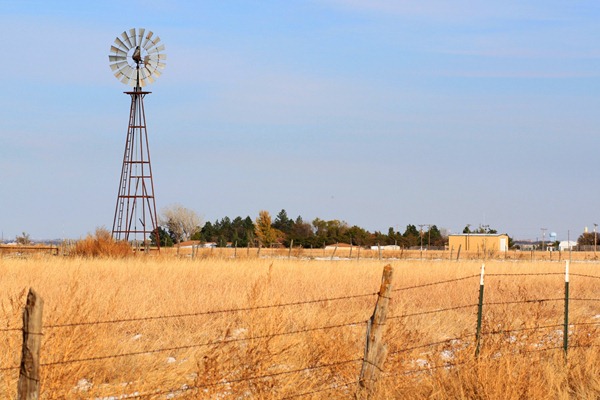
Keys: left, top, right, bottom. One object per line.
{"left": 355, "top": 264, "right": 393, "bottom": 399}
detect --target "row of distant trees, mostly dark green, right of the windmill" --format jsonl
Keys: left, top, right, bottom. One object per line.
{"left": 152, "top": 206, "right": 448, "bottom": 248}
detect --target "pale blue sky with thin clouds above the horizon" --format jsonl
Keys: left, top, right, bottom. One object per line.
{"left": 0, "top": 0, "right": 600, "bottom": 239}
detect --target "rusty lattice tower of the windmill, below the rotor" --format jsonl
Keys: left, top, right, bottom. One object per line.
{"left": 112, "top": 88, "right": 160, "bottom": 247}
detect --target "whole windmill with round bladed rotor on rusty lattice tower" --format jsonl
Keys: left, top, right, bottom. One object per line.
{"left": 108, "top": 28, "right": 167, "bottom": 247}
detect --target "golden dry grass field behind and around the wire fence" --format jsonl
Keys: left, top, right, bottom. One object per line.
{"left": 0, "top": 250, "right": 600, "bottom": 399}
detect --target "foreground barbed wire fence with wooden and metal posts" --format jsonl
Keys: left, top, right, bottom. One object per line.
{"left": 0, "top": 261, "right": 600, "bottom": 399}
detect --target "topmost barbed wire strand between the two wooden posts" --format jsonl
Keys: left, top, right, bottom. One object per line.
{"left": 44, "top": 292, "right": 377, "bottom": 329}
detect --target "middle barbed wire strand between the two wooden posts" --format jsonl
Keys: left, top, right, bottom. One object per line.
{"left": 40, "top": 320, "right": 367, "bottom": 367}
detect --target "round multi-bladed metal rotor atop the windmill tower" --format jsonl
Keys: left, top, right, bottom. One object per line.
{"left": 108, "top": 28, "right": 167, "bottom": 88}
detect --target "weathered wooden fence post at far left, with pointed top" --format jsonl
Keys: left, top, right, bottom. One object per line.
{"left": 17, "top": 288, "right": 44, "bottom": 400}
